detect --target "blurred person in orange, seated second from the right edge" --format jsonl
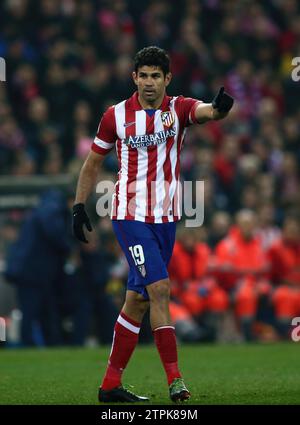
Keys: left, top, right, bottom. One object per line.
{"left": 215, "top": 210, "right": 271, "bottom": 341}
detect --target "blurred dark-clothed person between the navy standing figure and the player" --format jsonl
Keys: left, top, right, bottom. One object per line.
{"left": 64, "top": 225, "right": 119, "bottom": 345}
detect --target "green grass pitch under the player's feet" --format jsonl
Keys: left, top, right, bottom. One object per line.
{"left": 0, "top": 342, "right": 300, "bottom": 405}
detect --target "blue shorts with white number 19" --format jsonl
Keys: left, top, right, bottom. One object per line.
{"left": 112, "top": 220, "right": 176, "bottom": 299}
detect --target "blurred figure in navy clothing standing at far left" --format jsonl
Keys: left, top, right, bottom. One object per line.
{"left": 5, "top": 190, "right": 71, "bottom": 346}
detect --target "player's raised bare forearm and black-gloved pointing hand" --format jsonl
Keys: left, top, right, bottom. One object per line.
{"left": 195, "top": 87, "right": 234, "bottom": 124}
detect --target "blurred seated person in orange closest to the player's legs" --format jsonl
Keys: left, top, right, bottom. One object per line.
{"left": 169, "top": 225, "right": 228, "bottom": 341}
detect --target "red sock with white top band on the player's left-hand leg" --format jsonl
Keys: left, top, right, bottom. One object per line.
{"left": 101, "top": 312, "right": 141, "bottom": 390}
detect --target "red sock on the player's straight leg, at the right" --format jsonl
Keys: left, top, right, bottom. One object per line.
{"left": 153, "top": 326, "right": 181, "bottom": 385}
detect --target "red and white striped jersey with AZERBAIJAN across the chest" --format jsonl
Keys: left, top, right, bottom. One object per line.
{"left": 92, "top": 92, "right": 200, "bottom": 223}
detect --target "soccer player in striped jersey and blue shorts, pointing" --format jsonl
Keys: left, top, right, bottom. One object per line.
{"left": 73, "top": 46, "right": 233, "bottom": 402}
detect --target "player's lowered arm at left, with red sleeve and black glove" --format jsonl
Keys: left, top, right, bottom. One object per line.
{"left": 73, "top": 107, "right": 116, "bottom": 243}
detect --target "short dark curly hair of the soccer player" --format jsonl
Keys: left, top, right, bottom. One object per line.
{"left": 134, "top": 46, "right": 170, "bottom": 76}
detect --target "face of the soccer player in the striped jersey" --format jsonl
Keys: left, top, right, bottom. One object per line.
{"left": 132, "top": 65, "right": 171, "bottom": 103}
